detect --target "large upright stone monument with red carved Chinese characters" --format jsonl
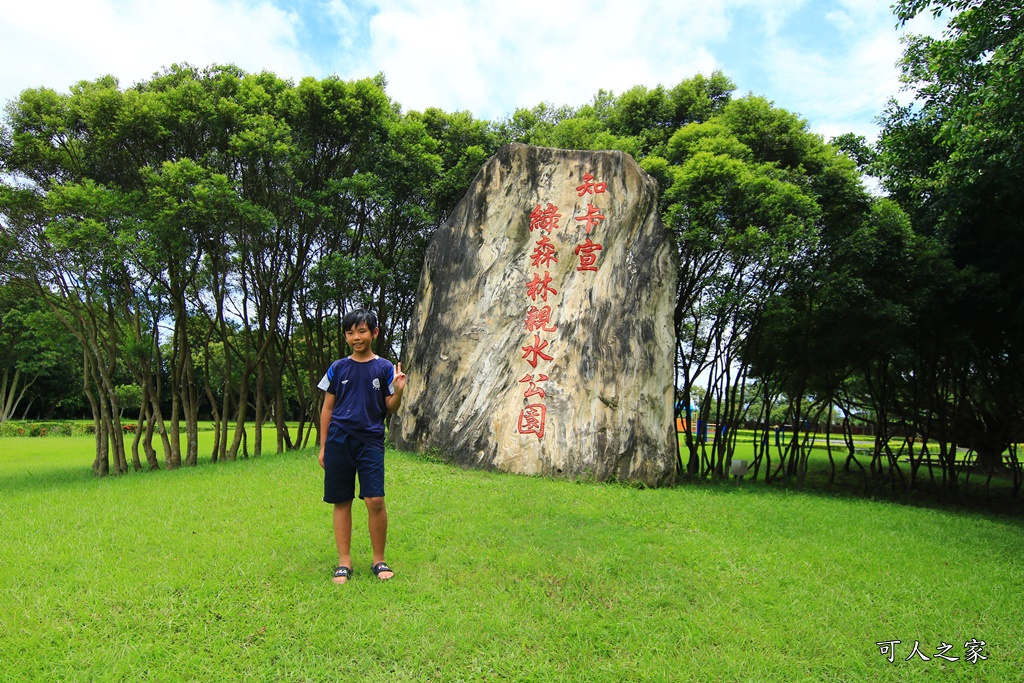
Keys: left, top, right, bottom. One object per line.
{"left": 390, "top": 144, "right": 676, "bottom": 485}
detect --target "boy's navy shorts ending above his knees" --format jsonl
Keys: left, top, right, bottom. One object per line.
{"left": 324, "top": 425, "right": 384, "bottom": 503}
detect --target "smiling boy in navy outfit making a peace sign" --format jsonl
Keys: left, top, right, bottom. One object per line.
{"left": 316, "top": 308, "right": 406, "bottom": 584}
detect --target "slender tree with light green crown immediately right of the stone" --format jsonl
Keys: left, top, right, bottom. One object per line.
{"left": 643, "top": 96, "right": 851, "bottom": 475}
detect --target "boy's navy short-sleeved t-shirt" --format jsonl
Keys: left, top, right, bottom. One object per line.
{"left": 316, "top": 356, "right": 394, "bottom": 451}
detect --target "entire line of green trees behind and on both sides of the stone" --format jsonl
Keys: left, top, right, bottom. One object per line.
{"left": 0, "top": 0, "right": 1024, "bottom": 490}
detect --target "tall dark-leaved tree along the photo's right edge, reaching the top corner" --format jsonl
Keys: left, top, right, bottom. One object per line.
{"left": 877, "top": 0, "right": 1024, "bottom": 468}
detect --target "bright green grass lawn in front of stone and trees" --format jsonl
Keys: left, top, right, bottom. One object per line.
{"left": 0, "top": 435, "right": 1024, "bottom": 683}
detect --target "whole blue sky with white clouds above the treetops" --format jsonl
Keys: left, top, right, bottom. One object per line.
{"left": 0, "top": 0, "right": 938, "bottom": 139}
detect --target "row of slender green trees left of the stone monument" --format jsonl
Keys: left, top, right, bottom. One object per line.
{"left": 0, "top": 66, "right": 495, "bottom": 475}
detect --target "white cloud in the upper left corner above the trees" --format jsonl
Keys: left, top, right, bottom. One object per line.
{"left": 0, "top": 0, "right": 309, "bottom": 100}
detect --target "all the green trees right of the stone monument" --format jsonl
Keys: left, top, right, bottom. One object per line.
{"left": 663, "top": 0, "right": 1024, "bottom": 494}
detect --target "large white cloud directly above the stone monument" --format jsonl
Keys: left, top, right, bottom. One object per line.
{"left": 348, "top": 0, "right": 728, "bottom": 118}
